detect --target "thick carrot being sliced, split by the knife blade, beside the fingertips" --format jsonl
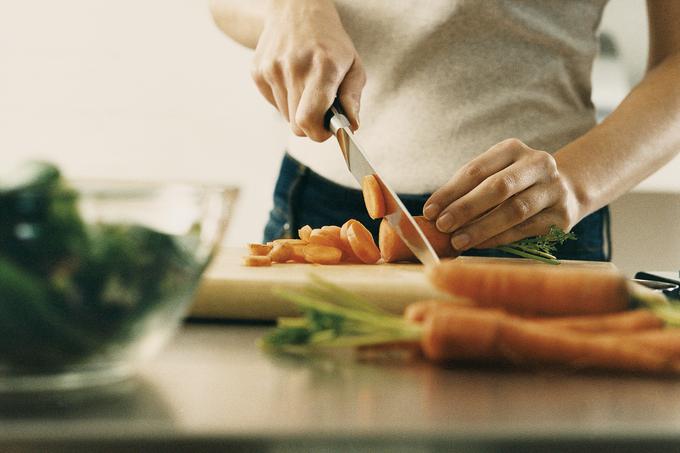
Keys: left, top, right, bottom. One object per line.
{"left": 378, "top": 216, "right": 454, "bottom": 263}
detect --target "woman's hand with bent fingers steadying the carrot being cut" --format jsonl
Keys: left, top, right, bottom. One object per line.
{"left": 423, "top": 139, "right": 585, "bottom": 251}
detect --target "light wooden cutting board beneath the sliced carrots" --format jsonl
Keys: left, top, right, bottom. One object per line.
{"left": 190, "top": 248, "right": 616, "bottom": 320}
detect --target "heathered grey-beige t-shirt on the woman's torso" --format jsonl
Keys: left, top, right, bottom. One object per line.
{"left": 288, "top": 0, "right": 607, "bottom": 193}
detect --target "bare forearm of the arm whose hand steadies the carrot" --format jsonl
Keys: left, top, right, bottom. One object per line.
{"left": 555, "top": 53, "right": 680, "bottom": 216}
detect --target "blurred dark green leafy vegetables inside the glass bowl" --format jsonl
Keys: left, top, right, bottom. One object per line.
{"left": 0, "top": 163, "right": 205, "bottom": 372}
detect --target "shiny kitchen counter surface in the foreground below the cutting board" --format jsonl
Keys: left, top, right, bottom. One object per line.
{"left": 0, "top": 323, "right": 680, "bottom": 452}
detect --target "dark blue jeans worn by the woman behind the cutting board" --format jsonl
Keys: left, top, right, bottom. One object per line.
{"left": 264, "top": 154, "right": 611, "bottom": 261}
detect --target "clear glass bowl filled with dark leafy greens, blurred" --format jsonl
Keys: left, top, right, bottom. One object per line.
{"left": 0, "top": 168, "right": 238, "bottom": 392}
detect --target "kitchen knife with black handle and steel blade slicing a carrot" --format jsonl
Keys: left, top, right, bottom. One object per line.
{"left": 325, "top": 99, "right": 439, "bottom": 266}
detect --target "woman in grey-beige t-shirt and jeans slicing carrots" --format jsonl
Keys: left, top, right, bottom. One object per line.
{"left": 212, "top": 0, "right": 680, "bottom": 260}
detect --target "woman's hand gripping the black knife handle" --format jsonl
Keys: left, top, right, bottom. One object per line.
{"left": 252, "top": 0, "right": 366, "bottom": 142}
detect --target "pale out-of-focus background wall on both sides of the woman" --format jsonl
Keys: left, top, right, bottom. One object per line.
{"left": 0, "top": 0, "right": 680, "bottom": 274}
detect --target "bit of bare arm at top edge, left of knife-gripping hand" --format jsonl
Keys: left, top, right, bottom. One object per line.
{"left": 210, "top": 0, "right": 268, "bottom": 49}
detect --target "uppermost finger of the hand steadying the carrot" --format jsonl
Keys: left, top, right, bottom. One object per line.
{"left": 423, "top": 139, "right": 525, "bottom": 221}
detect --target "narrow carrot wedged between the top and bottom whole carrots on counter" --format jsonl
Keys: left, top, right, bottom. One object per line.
{"left": 536, "top": 310, "right": 664, "bottom": 333}
